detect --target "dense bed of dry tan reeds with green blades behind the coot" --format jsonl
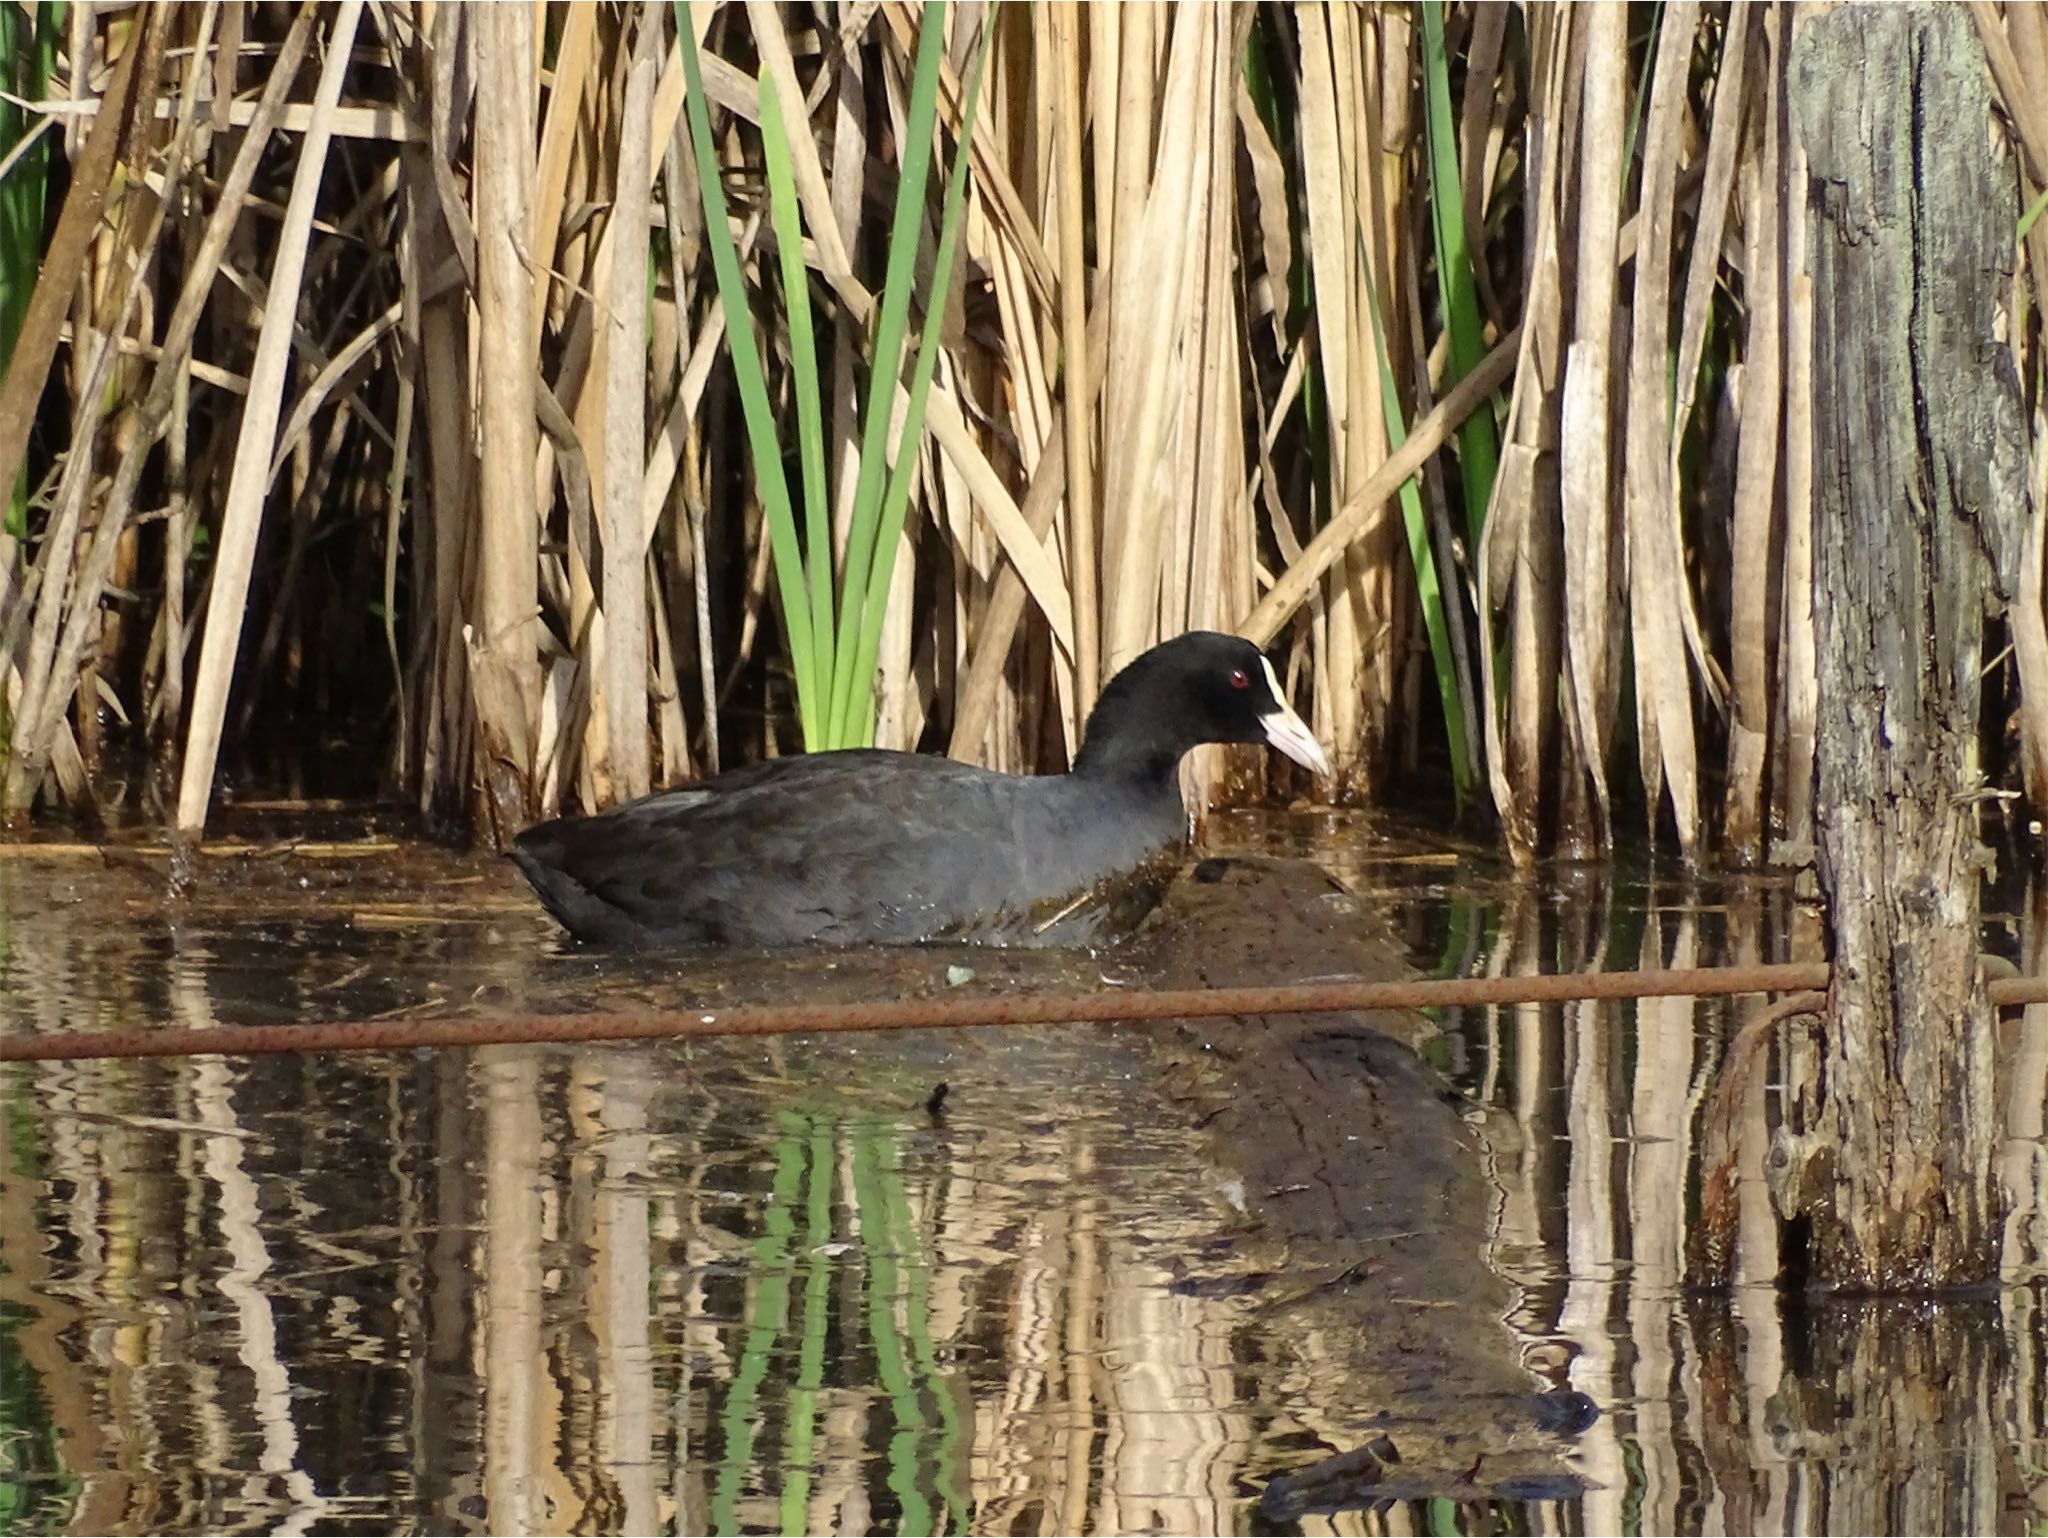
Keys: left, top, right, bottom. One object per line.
{"left": 0, "top": 0, "right": 2048, "bottom": 862}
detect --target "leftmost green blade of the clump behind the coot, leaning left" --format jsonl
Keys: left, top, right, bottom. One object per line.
{"left": 676, "top": 0, "right": 829, "bottom": 750}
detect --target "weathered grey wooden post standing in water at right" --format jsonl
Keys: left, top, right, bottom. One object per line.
{"left": 1774, "top": 4, "right": 2025, "bottom": 1290}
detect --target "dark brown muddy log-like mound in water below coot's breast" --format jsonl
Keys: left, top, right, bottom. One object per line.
{"left": 1126, "top": 858, "right": 1595, "bottom": 1520}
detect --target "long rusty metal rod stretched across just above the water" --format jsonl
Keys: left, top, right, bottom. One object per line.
{"left": 0, "top": 963, "right": 2048, "bottom": 1063}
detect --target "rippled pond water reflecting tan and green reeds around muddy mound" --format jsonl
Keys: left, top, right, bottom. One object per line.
{"left": 0, "top": 819, "right": 2048, "bottom": 1534}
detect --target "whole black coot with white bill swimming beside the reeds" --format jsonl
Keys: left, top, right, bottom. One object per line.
{"left": 512, "top": 631, "right": 1329, "bottom": 946}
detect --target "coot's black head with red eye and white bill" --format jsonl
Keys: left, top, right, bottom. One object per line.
{"left": 1073, "top": 631, "right": 1329, "bottom": 780}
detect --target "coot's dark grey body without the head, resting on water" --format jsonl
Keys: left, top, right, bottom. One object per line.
{"left": 512, "top": 750, "right": 1188, "bottom": 946}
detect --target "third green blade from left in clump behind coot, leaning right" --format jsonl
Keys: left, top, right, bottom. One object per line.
{"left": 829, "top": 0, "right": 946, "bottom": 741}
